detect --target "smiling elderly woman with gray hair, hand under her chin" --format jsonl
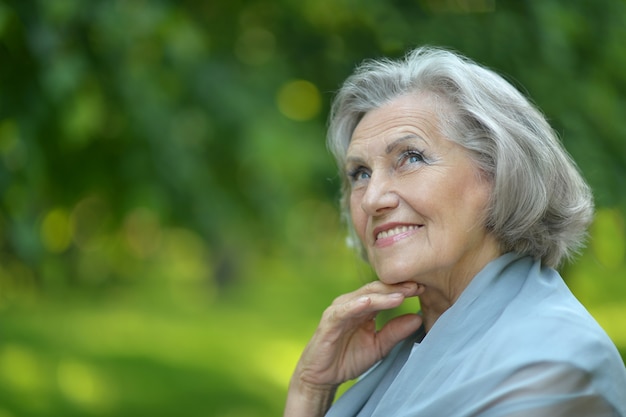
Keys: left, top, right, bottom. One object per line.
{"left": 285, "top": 48, "right": 626, "bottom": 417}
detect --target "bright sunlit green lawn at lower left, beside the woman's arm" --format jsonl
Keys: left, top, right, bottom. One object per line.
{"left": 0, "top": 290, "right": 302, "bottom": 417}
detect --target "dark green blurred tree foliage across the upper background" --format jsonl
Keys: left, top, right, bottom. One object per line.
{"left": 0, "top": 0, "right": 626, "bottom": 292}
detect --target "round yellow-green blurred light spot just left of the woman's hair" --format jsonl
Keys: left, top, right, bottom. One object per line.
{"left": 276, "top": 80, "right": 322, "bottom": 121}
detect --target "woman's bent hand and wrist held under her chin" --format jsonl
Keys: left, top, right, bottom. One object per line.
{"left": 285, "top": 281, "right": 423, "bottom": 417}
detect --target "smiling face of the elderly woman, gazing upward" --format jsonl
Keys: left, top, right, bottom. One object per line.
{"left": 346, "top": 95, "right": 499, "bottom": 287}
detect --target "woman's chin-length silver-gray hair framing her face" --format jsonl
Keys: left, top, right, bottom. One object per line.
{"left": 328, "top": 47, "right": 593, "bottom": 267}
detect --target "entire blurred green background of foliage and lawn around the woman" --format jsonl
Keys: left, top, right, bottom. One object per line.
{"left": 0, "top": 0, "right": 626, "bottom": 417}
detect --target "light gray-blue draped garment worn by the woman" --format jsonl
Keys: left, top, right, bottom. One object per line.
{"left": 327, "top": 254, "right": 626, "bottom": 417}
